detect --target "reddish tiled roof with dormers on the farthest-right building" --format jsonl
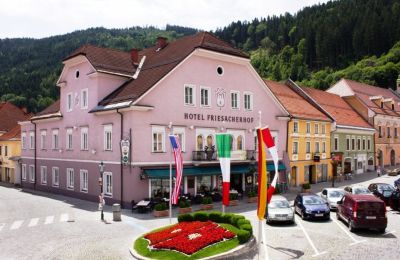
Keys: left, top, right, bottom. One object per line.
{"left": 342, "top": 79, "right": 400, "bottom": 116}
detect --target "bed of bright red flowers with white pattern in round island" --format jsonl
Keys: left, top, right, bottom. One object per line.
{"left": 145, "top": 221, "right": 235, "bottom": 255}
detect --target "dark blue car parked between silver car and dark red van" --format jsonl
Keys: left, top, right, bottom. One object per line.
{"left": 294, "top": 193, "right": 330, "bottom": 220}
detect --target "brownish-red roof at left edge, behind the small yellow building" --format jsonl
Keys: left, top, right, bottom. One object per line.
{"left": 0, "top": 102, "right": 30, "bottom": 132}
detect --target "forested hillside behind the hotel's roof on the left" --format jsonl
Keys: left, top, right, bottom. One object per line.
{"left": 0, "top": 25, "right": 197, "bottom": 112}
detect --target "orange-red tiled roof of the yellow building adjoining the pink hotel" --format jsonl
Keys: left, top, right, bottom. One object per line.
{"left": 264, "top": 80, "right": 331, "bottom": 121}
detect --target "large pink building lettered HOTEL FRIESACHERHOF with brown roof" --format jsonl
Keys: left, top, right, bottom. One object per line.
{"left": 20, "top": 32, "right": 288, "bottom": 206}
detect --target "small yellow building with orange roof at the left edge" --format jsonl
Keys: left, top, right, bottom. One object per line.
{"left": 0, "top": 125, "right": 21, "bottom": 184}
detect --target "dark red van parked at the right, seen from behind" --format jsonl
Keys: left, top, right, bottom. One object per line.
{"left": 336, "top": 193, "right": 387, "bottom": 233}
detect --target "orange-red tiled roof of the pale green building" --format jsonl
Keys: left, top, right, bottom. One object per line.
{"left": 302, "top": 87, "right": 372, "bottom": 128}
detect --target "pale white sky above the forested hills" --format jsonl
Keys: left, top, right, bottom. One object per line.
{"left": 0, "top": 0, "right": 327, "bottom": 39}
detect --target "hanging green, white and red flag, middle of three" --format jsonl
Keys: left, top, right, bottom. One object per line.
{"left": 216, "top": 134, "right": 232, "bottom": 206}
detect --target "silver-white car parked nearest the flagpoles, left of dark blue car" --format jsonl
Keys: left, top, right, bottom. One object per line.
{"left": 267, "top": 195, "right": 294, "bottom": 223}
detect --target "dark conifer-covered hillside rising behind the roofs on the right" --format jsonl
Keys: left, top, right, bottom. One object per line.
{"left": 216, "top": 0, "right": 400, "bottom": 88}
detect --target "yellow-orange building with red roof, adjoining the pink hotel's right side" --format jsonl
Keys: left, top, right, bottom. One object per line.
{"left": 265, "top": 80, "right": 333, "bottom": 186}
